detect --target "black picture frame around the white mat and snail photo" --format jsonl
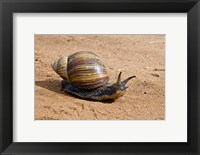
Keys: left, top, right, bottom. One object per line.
{"left": 0, "top": 0, "right": 200, "bottom": 155}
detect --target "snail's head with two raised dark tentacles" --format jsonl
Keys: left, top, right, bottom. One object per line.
{"left": 115, "top": 72, "right": 136, "bottom": 95}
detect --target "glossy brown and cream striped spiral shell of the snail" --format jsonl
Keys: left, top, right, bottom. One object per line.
{"left": 52, "top": 51, "right": 109, "bottom": 89}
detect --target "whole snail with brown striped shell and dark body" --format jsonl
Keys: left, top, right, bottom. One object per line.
{"left": 51, "top": 51, "right": 135, "bottom": 101}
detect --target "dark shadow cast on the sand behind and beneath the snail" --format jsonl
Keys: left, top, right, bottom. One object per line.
{"left": 35, "top": 80, "right": 114, "bottom": 104}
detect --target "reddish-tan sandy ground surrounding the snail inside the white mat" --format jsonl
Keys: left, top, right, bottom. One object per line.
{"left": 35, "top": 35, "right": 165, "bottom": 120}
